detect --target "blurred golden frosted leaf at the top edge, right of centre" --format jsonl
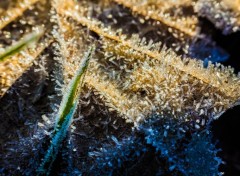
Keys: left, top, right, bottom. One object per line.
{"left": 113, "top": 0, "right": 198, "bottom": 36}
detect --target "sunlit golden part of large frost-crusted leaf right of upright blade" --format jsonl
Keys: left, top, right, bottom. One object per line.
{"left": 55, "top": 1, "right": 240, "bottom": 122}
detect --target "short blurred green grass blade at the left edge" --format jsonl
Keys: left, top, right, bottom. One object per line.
{"left": 0, "top": 28, "right": 43, "bottom": 62}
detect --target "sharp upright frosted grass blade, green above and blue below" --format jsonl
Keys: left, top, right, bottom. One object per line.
{"left": 37, "top": 46, "right": 95, "bottom": 175}
